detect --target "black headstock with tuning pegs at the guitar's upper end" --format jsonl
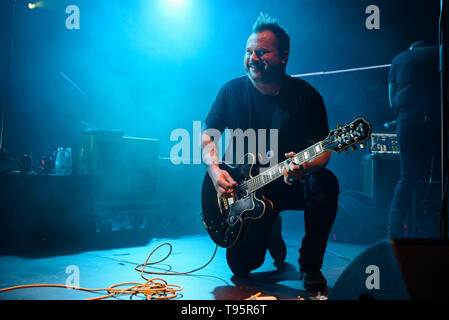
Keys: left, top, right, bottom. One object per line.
{"left": 322, "top": 118, "right": 371, "bottom": 153}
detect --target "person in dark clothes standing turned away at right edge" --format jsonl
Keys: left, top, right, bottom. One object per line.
{"left": 387, "top": 41, "right": 441, "bottom": 238}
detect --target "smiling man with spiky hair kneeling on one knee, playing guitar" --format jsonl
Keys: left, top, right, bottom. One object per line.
{"left": 202, "top": 14, "right": 339, "bottom": 291}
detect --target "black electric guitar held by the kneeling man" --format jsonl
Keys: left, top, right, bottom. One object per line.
{"left": 201, "top": 118, "right": 371, "bottom": 248}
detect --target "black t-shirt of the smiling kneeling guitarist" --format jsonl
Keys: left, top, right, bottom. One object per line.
{"left": 205, "top": 75, "right": 329, "bottom": 163}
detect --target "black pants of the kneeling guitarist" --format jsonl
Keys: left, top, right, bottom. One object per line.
{"left": 226, "top": 169, "right": 339, "bottom": 276}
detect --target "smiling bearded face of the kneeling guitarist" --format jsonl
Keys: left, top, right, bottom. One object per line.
{"left": 243, "top": 30, "right": 288, "bottom": 82}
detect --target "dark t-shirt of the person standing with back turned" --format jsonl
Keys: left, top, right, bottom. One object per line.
{"left": 388, "top": 46, "right": 440, "bottom": 121}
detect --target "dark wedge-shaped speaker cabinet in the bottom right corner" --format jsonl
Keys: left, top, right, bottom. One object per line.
{"left": 328, "top": 239, "right": 449, "bottom": 300}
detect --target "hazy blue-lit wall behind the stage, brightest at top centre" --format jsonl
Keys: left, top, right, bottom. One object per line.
{"left": 0, "top": 0, "right": 439, "bottom": 198}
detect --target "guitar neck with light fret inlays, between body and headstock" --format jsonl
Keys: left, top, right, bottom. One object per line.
{"left": 247, "top": 141, "right": 325, "bottom": 193}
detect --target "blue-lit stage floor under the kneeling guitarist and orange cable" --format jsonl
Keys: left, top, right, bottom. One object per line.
{"left": 0, "top": 221, "right": 366, "bottom": 300}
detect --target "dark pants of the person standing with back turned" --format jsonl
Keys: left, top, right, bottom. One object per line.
{"left": 387, "top": 116, "right": 441, "bottom": 238}
